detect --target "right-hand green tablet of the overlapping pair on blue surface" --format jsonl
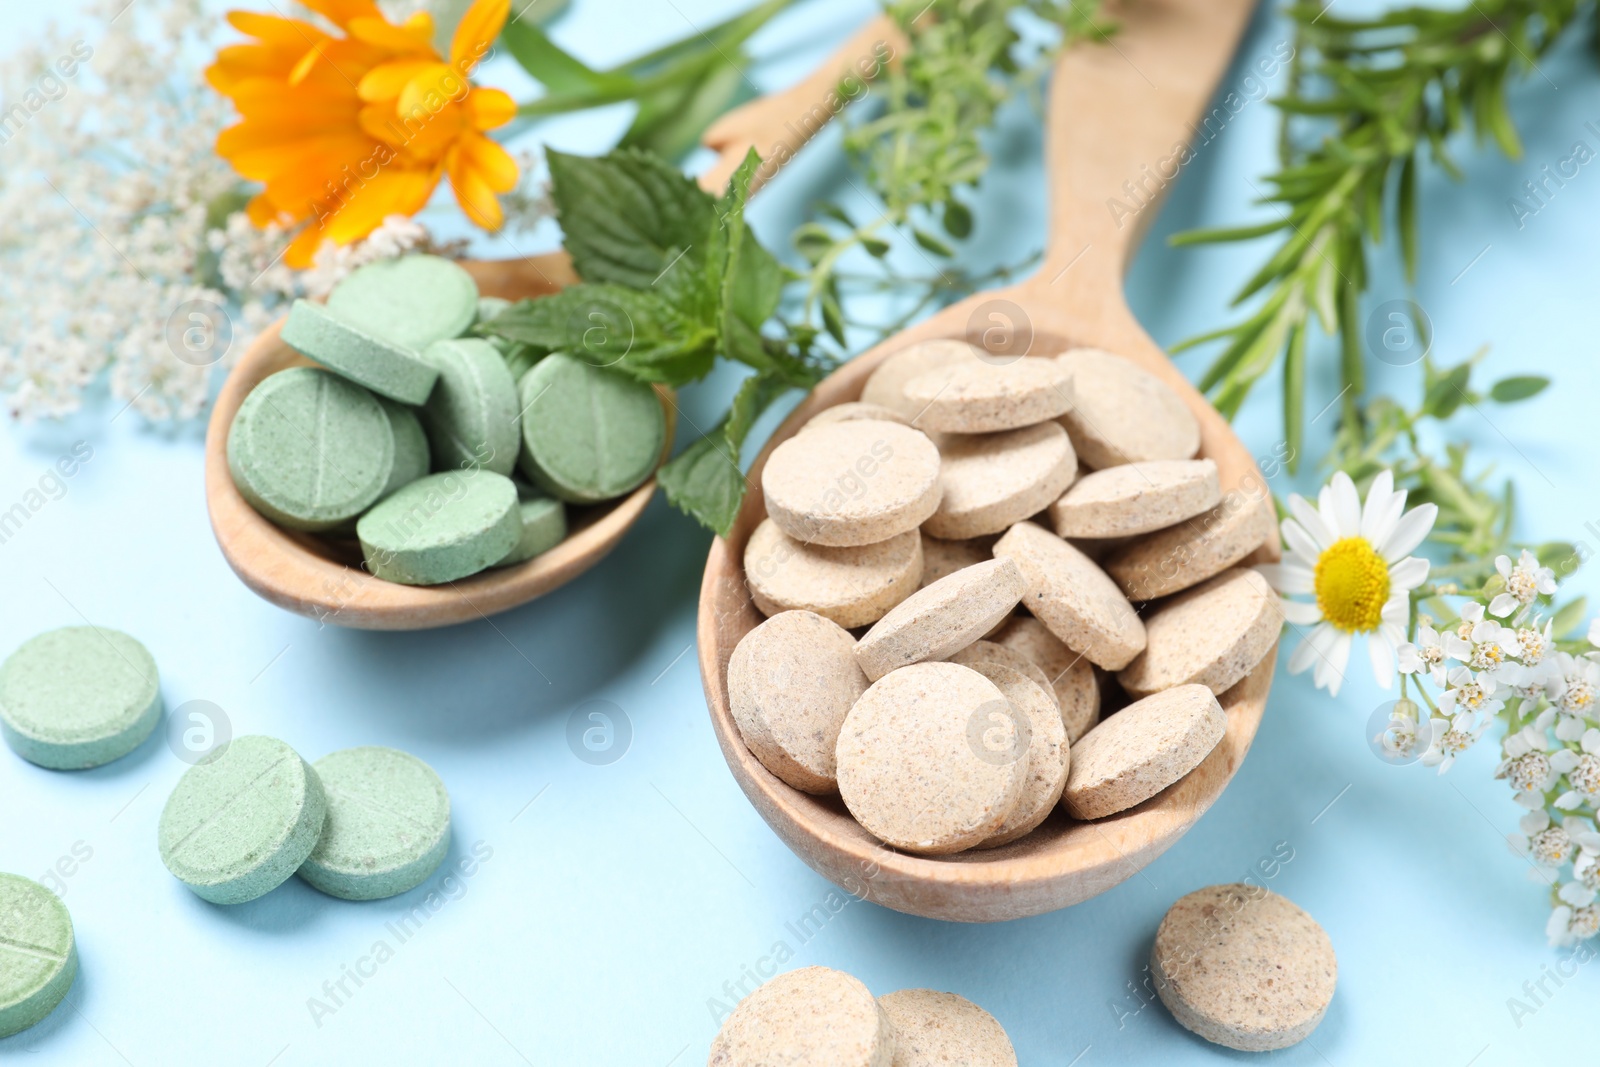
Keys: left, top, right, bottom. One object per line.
{"left": 296, "top": 745, "right": 450, "bottom": 901}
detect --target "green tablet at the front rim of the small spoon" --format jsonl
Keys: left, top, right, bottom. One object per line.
{"left": 355, "top": 470, "right": 522, "bottom": 585}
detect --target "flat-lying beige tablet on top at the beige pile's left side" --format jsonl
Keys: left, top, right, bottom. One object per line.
{"left": 762, "top": 419, "right": 941, "bottom": 547}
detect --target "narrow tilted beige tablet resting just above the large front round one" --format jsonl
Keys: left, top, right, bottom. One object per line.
{"left": 856, "top": 560, "right": 1022, "bottom": 681}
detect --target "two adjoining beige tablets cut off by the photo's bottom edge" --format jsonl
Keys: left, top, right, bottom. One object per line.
{"left": 707, "top": 966, "right": 1016, "bottom": 1067}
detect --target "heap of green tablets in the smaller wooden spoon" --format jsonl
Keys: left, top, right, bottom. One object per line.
{"left": 227, "top": 256, "right": 666, "bottom": 585}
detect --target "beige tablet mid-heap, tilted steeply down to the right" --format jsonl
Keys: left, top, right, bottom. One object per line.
{"left": 995, "top": 523, "right": 1144, "bottom": 670}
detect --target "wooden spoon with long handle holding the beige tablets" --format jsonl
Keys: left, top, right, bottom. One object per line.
{"left": 699, "top": 0, "right": 1275, "bottom": 921}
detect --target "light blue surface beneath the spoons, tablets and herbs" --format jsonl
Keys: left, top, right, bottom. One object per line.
{"left": 0, "top": 0, "right": 1600, "bottom": 1067}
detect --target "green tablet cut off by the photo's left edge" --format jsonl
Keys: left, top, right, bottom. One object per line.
{"left": 0, "top": 873, "right": 78, "bottom": 1037}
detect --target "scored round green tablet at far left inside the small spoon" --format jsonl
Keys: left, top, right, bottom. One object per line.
{"left": 227, "top": 366, "right": 395, "bottom": 531}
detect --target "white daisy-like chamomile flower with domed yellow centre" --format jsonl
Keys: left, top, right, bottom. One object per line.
{"left": 1259, "top": 470, "right": 1438, "bottom": 696}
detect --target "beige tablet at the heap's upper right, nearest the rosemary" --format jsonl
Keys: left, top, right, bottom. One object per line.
{"left": 1056, "top": 349, "right": 1200, "bottom": 470}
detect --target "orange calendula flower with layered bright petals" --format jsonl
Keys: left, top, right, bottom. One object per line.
{"left": 205, "top": 0, "right": 518, "bottom": 269}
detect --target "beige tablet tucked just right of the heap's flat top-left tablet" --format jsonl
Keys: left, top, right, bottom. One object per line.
{"left": 922, "top": 422, "right": 1078, "bottom": 539}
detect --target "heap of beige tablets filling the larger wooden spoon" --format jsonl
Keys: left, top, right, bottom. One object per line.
{"left": 728, "top": 341, "right": 1283, "bottom": 856}
